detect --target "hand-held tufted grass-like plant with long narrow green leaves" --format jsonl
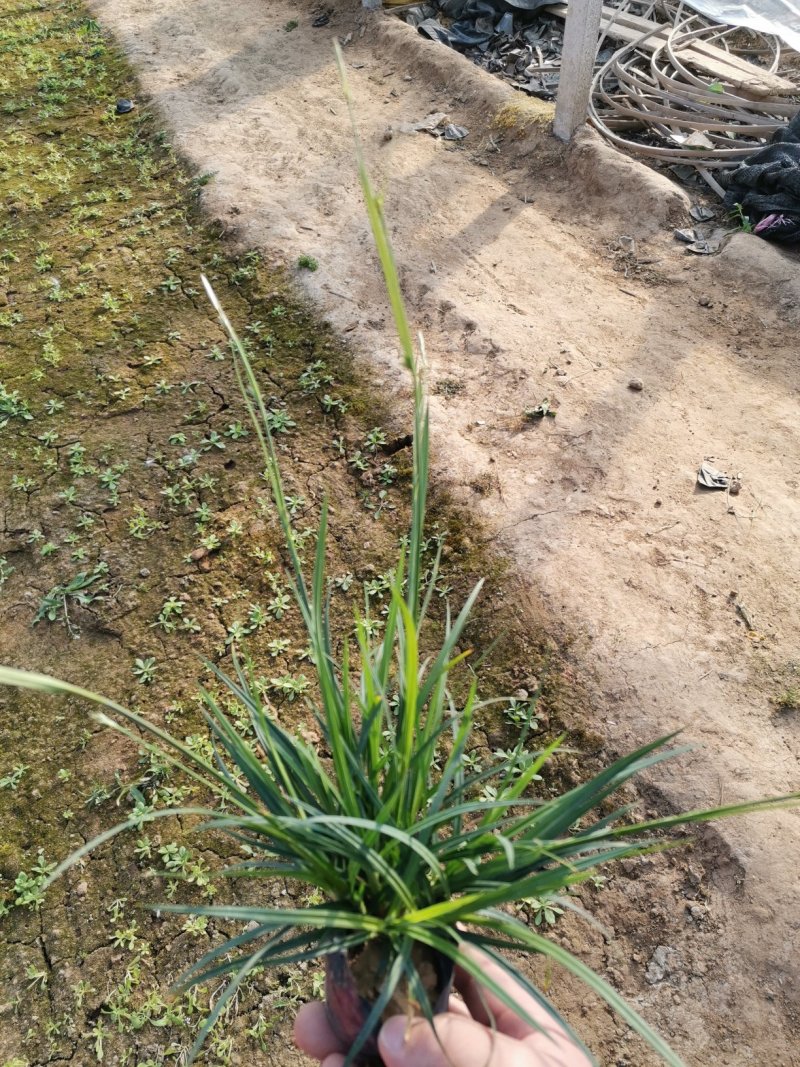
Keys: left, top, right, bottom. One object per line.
{"left": 0, "top": 48, "right": 800, "bottom": 1067}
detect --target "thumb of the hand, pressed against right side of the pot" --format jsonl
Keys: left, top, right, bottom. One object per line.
{"left": 378, "top": 1013, "right": 539, "bottom": 1067}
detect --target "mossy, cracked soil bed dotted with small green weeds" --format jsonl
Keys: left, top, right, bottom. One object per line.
{"left": 0, "top": 0, "right": 588, "bottom": 1067}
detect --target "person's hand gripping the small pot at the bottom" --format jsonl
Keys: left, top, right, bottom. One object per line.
{"left": 294, "top": 949, "right": 592, "bottom": 1067}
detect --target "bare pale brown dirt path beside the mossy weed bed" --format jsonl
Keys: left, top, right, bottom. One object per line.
{"left": 83, "top": 0, "right": 800, "bottom": 1067}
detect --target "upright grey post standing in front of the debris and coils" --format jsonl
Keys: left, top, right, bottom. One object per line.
{"left": 553, "top": 0, "right": 603, "bottom": 141}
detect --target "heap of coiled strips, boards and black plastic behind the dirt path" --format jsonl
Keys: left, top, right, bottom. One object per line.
{"left": 397, "top": 0, "right": 800, "bottom": 241}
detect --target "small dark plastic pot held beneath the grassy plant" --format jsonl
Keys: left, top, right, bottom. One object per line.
{"left": 325, "top": 940, "right": 453, "bottom": 1067}
